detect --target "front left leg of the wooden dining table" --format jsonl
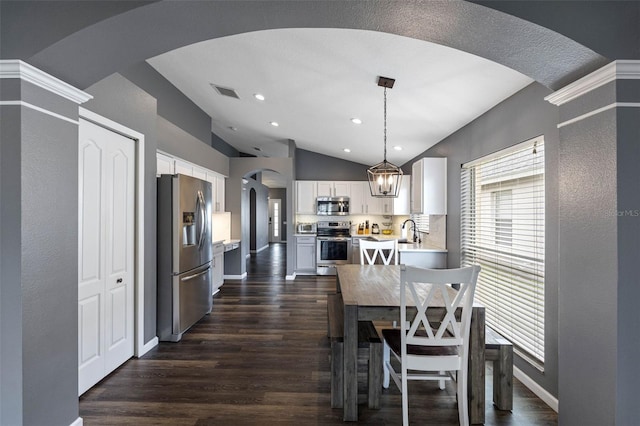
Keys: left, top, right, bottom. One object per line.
{"left": 342, "top": 303, "right": 358, "bottom": 421}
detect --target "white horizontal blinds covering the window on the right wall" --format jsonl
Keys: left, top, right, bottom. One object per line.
{"left": 460, "top": 137, "right": 544, "bottom": 368}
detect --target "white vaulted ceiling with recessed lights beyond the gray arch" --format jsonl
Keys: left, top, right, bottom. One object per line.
{"left": 148, "top": 28, "right": 533, "bottom": 185}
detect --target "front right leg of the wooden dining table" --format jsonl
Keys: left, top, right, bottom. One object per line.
{"left": 467, "top": 307, "right": 485, "bottom": 424}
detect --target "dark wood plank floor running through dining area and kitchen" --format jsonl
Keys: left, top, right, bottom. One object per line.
{"left": 80, "top": 244, "right": 557, "bottom": 426}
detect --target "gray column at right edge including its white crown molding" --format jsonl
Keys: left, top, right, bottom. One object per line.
{"left": 545, "top": 60, "right": 640, "bottom": 424}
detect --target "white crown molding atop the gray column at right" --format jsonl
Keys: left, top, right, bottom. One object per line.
{"left": 544, "top": 60, "right": 640, "bottom": 106}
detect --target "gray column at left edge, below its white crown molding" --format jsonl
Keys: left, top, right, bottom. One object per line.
{"left": 0, "top": 80, "right": 78, "bottom": 425}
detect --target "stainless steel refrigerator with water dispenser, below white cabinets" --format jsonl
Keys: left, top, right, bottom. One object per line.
{"left": 157, "top": 174, "right": 213, "bottom": 342}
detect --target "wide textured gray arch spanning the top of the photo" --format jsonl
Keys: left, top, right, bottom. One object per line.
{"left": 23, "top": 1, "right": 608, "bottom": 89}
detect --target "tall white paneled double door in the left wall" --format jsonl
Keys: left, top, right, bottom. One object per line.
{"left": 78, "top": 119, "right": 136, "bottom": 394}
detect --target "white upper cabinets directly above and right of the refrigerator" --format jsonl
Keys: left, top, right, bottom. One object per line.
{"left": 156, "top": 152, "right": 225, "bottom": 213}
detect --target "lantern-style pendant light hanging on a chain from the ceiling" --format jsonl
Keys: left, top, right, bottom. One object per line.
{"left": 367, "top": 77, "right": 402, "bottom": 198}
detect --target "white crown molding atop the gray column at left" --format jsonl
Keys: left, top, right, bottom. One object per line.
{"left": 0, "top": 59, "right": 93, "bottom": 104}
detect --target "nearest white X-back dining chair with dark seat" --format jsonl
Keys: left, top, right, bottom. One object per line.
{"left": 382, "top": 265, "right": 480, "bottom": 426}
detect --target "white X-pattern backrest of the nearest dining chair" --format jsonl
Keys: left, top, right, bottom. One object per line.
{"left": 400, "top": 265, "right": 480, "bottom": 352}
